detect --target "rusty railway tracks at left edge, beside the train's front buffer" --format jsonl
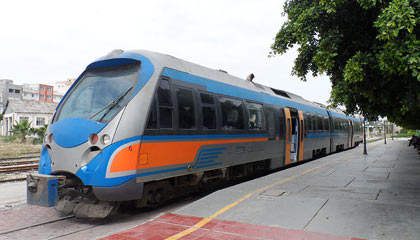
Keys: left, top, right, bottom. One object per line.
{"left": 0, "top": 156, "right": 39, "bottom": 183}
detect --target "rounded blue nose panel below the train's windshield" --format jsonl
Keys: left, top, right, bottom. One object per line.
{"left": 50, "top": 118, "right": 106, "bottom": 148}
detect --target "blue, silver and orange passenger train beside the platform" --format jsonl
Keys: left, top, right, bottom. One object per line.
{"left": 28, "top": 50, "right": 363, "bottom": 218}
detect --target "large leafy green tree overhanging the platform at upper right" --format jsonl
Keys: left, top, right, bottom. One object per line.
{"left": 270, "top": 0, "right": 420, "bottom": 128}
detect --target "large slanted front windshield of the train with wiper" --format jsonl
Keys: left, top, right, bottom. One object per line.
{"left": 57, "top": 63, "right": 140, "bottom": 122}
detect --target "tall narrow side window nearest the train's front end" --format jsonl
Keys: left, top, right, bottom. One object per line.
{"left": 158, "top": 79, "right": 173, "bottom": 128}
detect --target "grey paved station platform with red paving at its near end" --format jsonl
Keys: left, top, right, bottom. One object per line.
{"left": 102, "top": 139, "right": 420, "bottom": 240}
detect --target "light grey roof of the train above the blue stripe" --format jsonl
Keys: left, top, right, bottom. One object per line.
{"left": 101, "top": 50, "right": 358, "bottom": 122}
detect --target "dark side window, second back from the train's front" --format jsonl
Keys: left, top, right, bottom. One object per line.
{"left": 175, "top": 88, "right": 196, "bottom": 129}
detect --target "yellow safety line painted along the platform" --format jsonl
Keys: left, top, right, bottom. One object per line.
{"left": 165, "top": 162, "right": 332, "bottom": 240}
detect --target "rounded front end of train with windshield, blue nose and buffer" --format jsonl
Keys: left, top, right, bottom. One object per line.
{"left": 27, "top": 51, "right": 154, "bottom": 218}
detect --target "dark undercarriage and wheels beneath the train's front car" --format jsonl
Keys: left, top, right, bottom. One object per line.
{"left": 42, "top": 160, "right": 270, "bottom": 218}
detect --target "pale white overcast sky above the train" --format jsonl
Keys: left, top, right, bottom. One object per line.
{"left": 0, "top": 0, "right": 331, "bottom": 104}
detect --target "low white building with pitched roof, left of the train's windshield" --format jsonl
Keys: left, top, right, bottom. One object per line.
{"left": 0, "top": 100, "right": 58, "bottom": 136}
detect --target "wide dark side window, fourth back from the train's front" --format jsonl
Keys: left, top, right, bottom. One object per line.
{"left": 219, "top": 97, "right": 244, "bottom": 129}
